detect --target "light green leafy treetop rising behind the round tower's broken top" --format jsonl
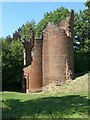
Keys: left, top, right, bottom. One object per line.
{"left": 36, "top": 7, "right": 70, "bottom": 37}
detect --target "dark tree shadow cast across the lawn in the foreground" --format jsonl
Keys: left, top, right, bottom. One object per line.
{"left": 2, "top": 95, "right": 88, "bottom": 118}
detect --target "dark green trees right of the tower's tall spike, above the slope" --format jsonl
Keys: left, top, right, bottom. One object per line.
{"left": 74, "top": 2, "right": 90, "bottom": 72}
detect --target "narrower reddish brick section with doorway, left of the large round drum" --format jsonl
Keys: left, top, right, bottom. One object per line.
{"left": 24, "top": 39, "right": 42, "bottom": 92}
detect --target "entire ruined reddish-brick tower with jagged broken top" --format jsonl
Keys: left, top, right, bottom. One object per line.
{"left": 21, "top": 11, "right": 74, "bottom": 92}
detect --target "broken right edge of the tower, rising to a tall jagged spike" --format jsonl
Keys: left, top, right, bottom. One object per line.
{"left": 59, "top": 11, "right": 74, "bottom": 80}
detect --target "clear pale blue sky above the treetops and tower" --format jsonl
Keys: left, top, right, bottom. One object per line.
{"left": 0, "top": 2, "right": 85, "bottom": 37}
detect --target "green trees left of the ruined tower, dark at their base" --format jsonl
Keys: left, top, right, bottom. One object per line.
{"left": 0, "top": 20, "right": 35, "bottom": 88}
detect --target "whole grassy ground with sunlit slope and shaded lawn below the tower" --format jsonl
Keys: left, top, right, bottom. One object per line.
{"left": 2, "top": 74, "right": 89, "bottom": 119}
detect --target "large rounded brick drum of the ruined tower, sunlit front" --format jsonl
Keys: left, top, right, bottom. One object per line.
{"left": 43, "top": 24, "right": 68, "bottom": 85}
